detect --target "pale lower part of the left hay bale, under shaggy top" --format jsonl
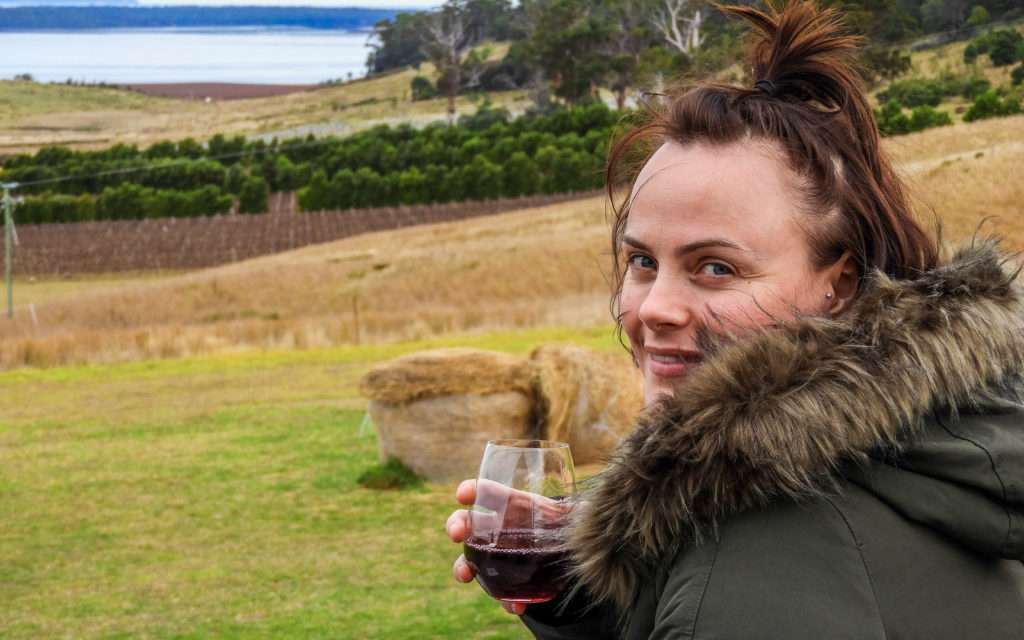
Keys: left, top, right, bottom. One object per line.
{"left": 370, "top": 391, "right": 535, "bottom": 480}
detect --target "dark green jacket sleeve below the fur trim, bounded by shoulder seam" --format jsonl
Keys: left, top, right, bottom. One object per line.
{"left": 647, "top": 500, "right": 886, "bottom": 640}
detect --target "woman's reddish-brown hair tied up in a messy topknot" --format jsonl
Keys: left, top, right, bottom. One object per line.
{"left": 606, "top": 0, "right": 938, "bottom": 317}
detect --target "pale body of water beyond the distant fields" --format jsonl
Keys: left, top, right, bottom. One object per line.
{"left": 0, "top": 29, "right": 370, "bottom": 84}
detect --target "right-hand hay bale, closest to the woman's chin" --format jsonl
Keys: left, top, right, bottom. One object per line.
{"left": 529, "top": 344, "right": 643, "bottom": 465}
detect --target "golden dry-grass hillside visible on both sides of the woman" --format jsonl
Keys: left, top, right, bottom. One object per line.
{"left": 0, "top": 111, "right": 1024, "bottom": 368}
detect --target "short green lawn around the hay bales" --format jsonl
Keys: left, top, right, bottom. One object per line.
{"left": 0, "top": 327, "right": 617, "bottom": 639}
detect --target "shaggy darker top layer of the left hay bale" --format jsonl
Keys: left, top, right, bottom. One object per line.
{"left": 359, "top": 348, "right": 531, "bottom": 404}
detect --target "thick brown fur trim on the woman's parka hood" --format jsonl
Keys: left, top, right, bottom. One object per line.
{"left": 571, "top": 242, "right": 1024, "bottom": 609}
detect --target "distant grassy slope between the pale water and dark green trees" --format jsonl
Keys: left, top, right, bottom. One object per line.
{"left": 0, "top": 45, "right": 529, "bottom": 157}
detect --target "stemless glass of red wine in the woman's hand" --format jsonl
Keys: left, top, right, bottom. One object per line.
{"left": 465, "top": 440, "right": 575, "bottom": 602}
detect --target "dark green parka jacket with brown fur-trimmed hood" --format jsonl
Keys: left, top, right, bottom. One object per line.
{"left": 523, "top": 244, "right": 1024, "bottom": 640}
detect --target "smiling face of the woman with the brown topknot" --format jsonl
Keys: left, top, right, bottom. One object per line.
{"left": 620, "top": 142, "right": 835, "bottom": 407}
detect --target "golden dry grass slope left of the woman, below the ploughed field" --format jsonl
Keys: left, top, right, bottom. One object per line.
{"left": 0, "top": 199, "right": 608, "bottom": 368}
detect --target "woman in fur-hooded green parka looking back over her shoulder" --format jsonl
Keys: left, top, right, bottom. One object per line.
{"left": 447, "top": 3, "right": 1024, "bottom": 640}
